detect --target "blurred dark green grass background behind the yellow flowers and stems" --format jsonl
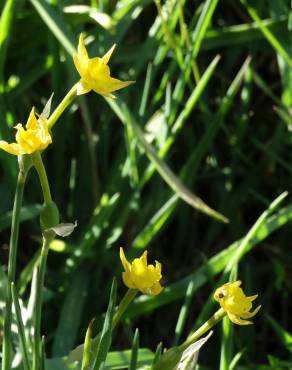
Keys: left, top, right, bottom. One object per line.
{"left": 0, "top": 0, "right": 292, "bottom": 370}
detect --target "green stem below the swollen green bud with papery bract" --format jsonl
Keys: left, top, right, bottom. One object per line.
{"left": 32, "top": 235, "right": 53, "bottom": 370}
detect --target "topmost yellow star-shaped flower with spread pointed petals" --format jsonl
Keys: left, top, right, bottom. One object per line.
{"left": 74, "top": 34, "right": 134, "bottom": 97}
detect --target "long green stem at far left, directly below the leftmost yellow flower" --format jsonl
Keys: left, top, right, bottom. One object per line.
{"left": 2, "top": 167, "right": 29, "bottom": 370}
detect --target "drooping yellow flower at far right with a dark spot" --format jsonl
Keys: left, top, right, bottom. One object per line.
{"left": 214, "top": 281, "right": 261, "bottom": 325}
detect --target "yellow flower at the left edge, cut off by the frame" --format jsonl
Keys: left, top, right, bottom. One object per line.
{"left": 0, "top": 108, "right": 52, "bottom": 155}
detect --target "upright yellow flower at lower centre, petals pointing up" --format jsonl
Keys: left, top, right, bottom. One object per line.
{"left": 120, "top": 248, "right": 162, "bottom": 295}
